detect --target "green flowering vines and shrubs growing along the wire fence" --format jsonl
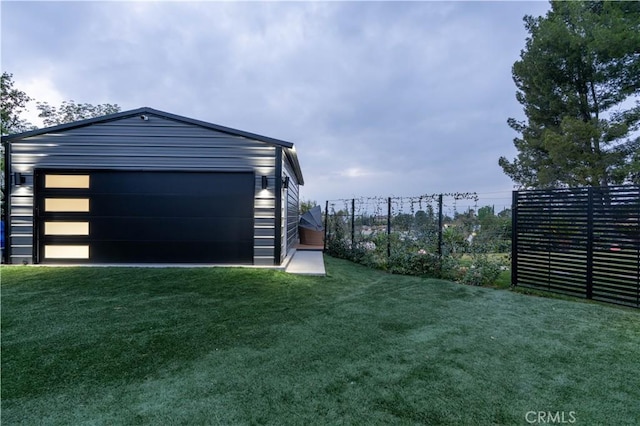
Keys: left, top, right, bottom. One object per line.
{"left": 325, "top": 192, "right": 511, "bottom": 285}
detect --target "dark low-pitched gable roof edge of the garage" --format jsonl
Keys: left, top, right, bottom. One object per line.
{"left": 2, "top": 107, "right": 304, "bottom": 185}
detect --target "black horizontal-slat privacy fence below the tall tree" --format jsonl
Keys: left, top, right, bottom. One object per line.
{"left": 511, "top": 185, "right": 640, "bottom": 308}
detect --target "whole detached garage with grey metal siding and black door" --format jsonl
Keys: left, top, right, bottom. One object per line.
{"left": 2, "top": 108, "right": 304, "bottom": 266}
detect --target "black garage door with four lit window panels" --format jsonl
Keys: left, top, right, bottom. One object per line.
{"left": 36, "top": 170, "right": 255, "bottom": 264}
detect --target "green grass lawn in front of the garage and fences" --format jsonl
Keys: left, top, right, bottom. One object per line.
{"left": 2, "top": 258, "right": 640, "bottom": 425}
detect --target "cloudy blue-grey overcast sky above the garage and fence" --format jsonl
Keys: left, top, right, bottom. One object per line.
{"left": 0, "top": 1, "right": 550, "bottom": 208}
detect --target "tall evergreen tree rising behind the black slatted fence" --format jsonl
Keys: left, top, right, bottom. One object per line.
{"left": 499, "top": 1, "right": 640, "bottom": 187}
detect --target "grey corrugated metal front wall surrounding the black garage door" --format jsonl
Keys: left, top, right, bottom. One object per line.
{"left": 9, "top": 114, "right": 276, "bottom": 265}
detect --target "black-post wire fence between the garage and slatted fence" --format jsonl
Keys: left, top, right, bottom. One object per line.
{"left": 324, "top": 192, "right": 511, "bottom": 266}
